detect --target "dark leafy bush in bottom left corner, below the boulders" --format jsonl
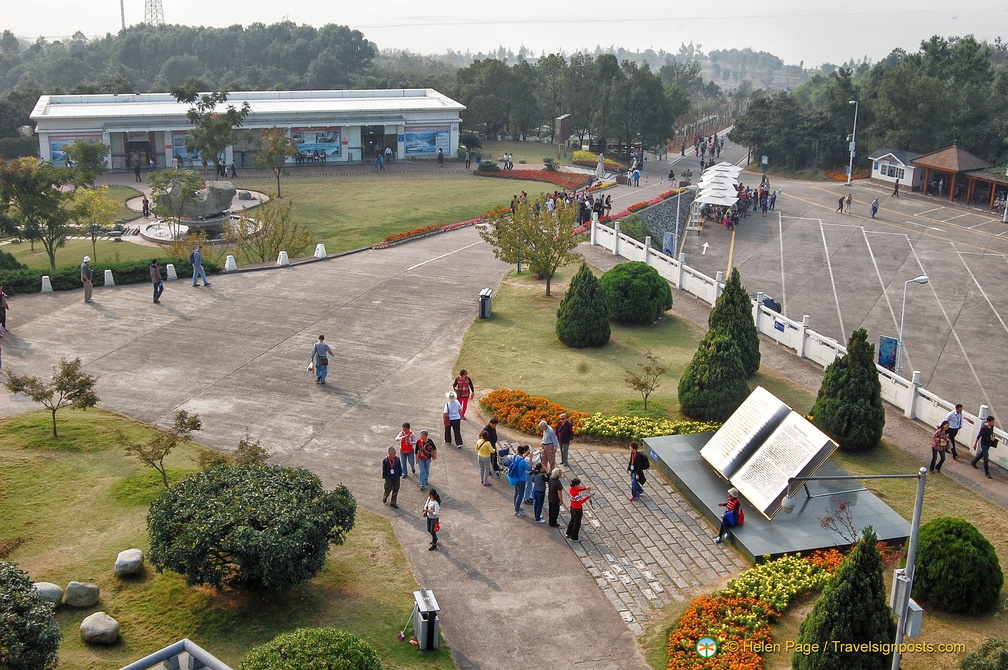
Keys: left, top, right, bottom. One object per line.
{"left": 0, "top": 561, "right": 62, "bottom": 670}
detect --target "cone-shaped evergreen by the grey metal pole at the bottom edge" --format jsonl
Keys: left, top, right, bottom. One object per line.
{"left": 791, "top": 527, "right": 896, "bottom": 670}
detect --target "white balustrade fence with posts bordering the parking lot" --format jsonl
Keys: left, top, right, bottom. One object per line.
{"left": 591, "top": 221, "right": 1008, "bottom": 467}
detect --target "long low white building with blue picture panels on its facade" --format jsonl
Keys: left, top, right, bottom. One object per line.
{"left": 31, "top": 89, "right": 466, "bottom": 170}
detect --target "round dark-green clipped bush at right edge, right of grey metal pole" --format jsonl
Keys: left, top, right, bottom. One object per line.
{"left": 913, "top": 517, "right": 1004, "bottom": 615}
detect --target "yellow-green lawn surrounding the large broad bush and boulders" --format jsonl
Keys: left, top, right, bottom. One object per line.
{"left": 0, "top": 410, "right": 455, "bottom": 670}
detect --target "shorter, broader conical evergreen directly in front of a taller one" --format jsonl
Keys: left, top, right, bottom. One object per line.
{"left": 679, "top": 330, "right": 749, "bottom": 421}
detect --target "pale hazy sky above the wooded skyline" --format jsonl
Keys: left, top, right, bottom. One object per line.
{"left": 0, "top": 0, "right": 1008, "bottom": 66}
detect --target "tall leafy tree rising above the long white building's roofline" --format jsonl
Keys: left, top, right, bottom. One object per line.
{"left": 170, "top": 80, "right": 252, "bottom": 173}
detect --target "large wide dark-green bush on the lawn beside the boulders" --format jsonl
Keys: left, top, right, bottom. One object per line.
{"left": 147, "top": 465, "right": 357, "bottom": 590}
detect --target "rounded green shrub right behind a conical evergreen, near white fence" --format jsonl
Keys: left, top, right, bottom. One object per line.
{"left": 599, "top": 261, "right": 672, "bottom": 325}
